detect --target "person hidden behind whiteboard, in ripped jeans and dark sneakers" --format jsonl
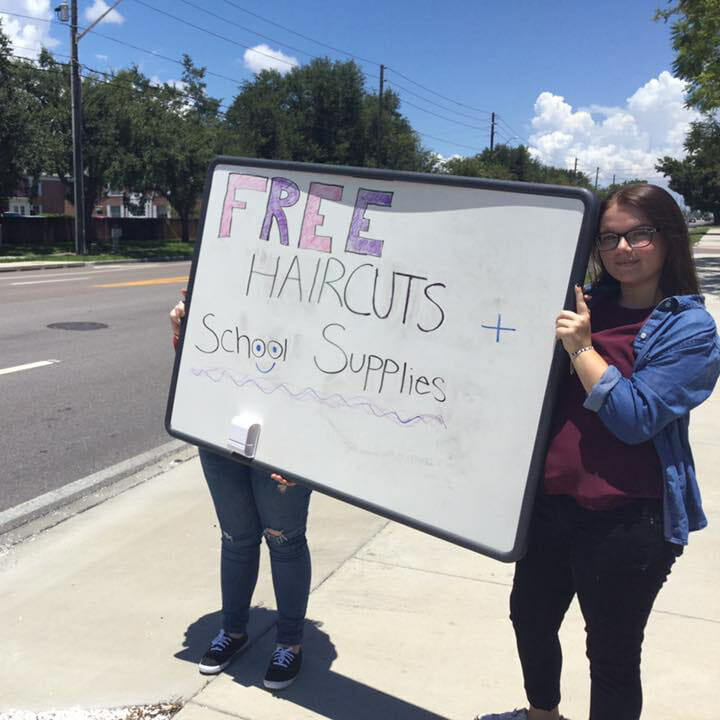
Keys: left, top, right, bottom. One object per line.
{"left": 170, "top": 291, "right": 310, "bottom": 690}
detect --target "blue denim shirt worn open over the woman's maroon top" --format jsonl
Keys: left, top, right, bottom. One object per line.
{"left": 583, "top": 288, "right": 720, "bottom": 545}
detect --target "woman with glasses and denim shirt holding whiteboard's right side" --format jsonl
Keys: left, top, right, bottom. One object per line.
{"left": 483, "top": 185, "right": 720, "bottom": 720}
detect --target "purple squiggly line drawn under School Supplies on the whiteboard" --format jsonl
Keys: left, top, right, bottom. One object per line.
{"left": 190, "top": 368, "right": 447, "bottom": 428}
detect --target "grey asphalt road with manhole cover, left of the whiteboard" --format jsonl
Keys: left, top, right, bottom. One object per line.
{"left": 0, "top": 262, "right": 190, "bottom": 512}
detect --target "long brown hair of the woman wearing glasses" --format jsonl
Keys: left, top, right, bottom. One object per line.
{"left": 591, "top": 183, "right": 700, "bottom": 297}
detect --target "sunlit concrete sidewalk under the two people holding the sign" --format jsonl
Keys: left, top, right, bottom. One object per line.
{"left": 0, "top": 284, "right": 720, "bottom": 720}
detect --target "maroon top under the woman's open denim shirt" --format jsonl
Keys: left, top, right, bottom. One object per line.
{"left": 544, "top": 301, "right": 662, "bottom": 510}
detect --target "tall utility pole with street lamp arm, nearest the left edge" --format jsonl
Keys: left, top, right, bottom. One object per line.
{"left": 55, "top": 0, "right": 122, "bottom": 255}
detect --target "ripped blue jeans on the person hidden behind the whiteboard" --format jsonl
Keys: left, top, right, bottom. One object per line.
{"left": 200, "top": 448, "right": 311, "bottom": 645}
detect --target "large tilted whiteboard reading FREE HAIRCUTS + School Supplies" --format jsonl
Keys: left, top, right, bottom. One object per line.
{"left": 166, "top": 158, "right": 596, "bottom": 560}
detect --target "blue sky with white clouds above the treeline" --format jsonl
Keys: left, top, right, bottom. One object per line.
{"left": 0, "top": 0, "right": 696, "bottom": 183}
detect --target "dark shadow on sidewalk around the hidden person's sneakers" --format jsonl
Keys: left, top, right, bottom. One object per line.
{"left": 175, "top": 608, "right": 447, "bottom": 720}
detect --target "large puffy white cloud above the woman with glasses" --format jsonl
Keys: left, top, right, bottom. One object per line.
{"left": 529, "top": 71, "right": 700, "bottom": 184}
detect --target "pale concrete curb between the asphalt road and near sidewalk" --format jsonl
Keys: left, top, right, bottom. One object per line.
{"left": 0, "top": 440, "right": 197, "bottom": 546}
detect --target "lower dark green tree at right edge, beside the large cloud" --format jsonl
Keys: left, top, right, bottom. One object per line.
{"left": 655, "top": 118, "right": 720, "bottom": 225}
